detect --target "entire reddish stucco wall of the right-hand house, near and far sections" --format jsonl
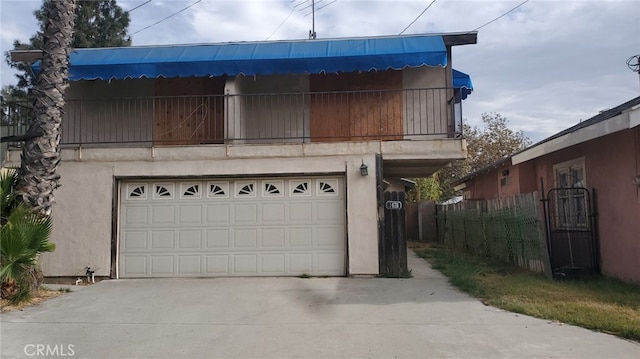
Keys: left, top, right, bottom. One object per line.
{"left": 465, "top": 128, "right": 640, "bottom": 283}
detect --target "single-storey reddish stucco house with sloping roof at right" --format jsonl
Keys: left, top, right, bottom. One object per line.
{"left": 457, "top": 97, "right": 640, "bottom": 283}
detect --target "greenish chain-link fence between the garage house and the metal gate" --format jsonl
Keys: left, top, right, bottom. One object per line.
{"left": 436, "top": 192, "right": 550, "bottom": 274}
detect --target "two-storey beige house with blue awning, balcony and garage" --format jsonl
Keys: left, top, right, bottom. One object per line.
{"left": 5, "top": 32, "right": 477, "bottom": 278}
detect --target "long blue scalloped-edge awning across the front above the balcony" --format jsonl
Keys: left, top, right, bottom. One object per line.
{"left": 34, "top": 35, "right": 447, "bottom": 80}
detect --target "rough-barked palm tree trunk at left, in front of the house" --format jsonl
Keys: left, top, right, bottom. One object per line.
{"left": 19, "top": 0, "right": 76, "bottom": 216}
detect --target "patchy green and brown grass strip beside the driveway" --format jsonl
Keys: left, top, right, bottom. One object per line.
{"left": 411, "top": 243, "right": 640, "bottom": 341}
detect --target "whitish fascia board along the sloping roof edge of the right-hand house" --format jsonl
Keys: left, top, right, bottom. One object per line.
{"left": 511, "top": 110, "right": 636, "bottom": 165}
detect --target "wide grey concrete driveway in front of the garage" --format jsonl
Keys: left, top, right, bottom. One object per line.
{"left": 0, "top": 252, "right": 640, "bottom": 359}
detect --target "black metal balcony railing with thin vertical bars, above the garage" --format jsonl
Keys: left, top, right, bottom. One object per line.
{"left": 1, "top": 88, "right": 462, "bottom": 146}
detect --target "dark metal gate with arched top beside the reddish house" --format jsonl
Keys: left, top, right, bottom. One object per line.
{"left": 543, "top": 187, "right": 600, "bottom": 278}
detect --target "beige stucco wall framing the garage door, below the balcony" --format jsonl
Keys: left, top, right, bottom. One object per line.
{"left": 9, "top": 144, "right": 378, "bottom": 276}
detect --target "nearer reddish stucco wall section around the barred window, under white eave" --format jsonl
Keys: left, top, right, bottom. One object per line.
{"left": 535, "top": 129, "right": 640, "bottom": 283}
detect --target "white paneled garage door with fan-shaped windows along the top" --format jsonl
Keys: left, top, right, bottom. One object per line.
{"left": 118, "top": 177, "right": 346, "bottom": 278}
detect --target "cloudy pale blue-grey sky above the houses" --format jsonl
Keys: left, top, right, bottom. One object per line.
{"left": 0, "top": 0, "right": 640, "bottom": 142}
